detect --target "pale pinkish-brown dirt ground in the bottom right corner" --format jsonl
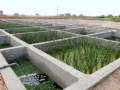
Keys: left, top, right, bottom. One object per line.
{"left": 91, "top": 69, "right": 120, "bottom": 90}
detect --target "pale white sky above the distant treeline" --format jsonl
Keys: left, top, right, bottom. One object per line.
{"left": 0, "top": 0, "right": 120, "bottom": 16}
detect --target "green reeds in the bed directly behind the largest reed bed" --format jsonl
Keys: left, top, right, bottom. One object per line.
{"left": 21, "top": 31, "right": 72, "bottom": 44}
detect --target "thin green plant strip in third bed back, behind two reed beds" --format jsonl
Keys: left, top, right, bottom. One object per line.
{"left": 6, "top": 27, "right": 46, "bottom": 34}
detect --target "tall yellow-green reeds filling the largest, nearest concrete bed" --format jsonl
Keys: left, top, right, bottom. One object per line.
{"left": 46, "top": 38, "right": 120, "bottom": 74}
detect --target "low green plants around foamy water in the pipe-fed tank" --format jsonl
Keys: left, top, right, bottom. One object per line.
{"left": 12, "top": 59, "right": 62, "bottom": 90}
